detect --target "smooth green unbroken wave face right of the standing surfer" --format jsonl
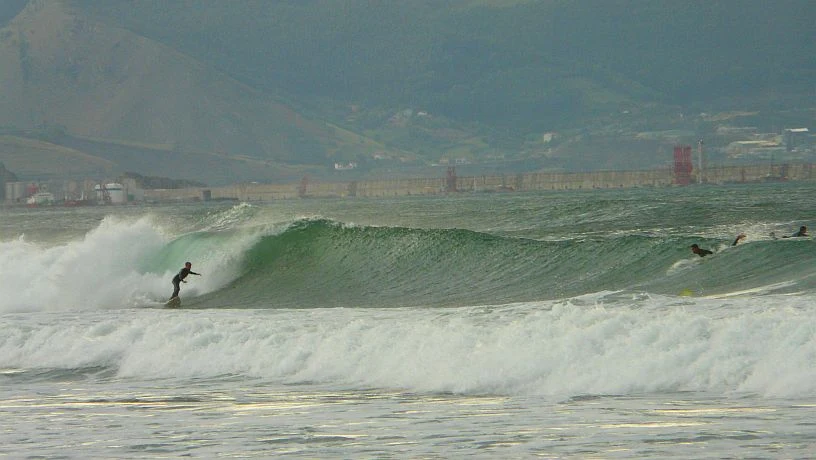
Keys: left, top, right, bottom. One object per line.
{"left": 178, "top": 219, "right": 816, "bottom": 308}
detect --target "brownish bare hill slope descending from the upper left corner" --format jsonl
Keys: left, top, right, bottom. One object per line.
{"left": 0, "top": 0, "right": 398, "bottom": 183}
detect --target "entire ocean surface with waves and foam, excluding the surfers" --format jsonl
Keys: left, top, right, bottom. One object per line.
{"left": 0, "top": 183, "right": 816, "bottom": 459}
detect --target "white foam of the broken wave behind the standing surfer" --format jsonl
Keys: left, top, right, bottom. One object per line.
{"left": 0, "top": 216, "right": 246, "bottom": 312}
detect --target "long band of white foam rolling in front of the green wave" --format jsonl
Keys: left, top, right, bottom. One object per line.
{"left": 0, "top": 296, "right": 816, "bottom": 397}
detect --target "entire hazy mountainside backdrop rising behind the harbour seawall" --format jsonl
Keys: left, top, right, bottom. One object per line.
{"left": 0, "top": 0, "right": 816, "bottom": 184}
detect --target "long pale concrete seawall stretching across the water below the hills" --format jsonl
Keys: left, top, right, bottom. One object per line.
{"left": 145, "top": 163, "right": 816, "bottom": 201}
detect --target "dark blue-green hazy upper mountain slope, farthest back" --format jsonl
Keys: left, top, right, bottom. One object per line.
{"left": 72, "top": 0, "right": 816, "bottom": 131}
